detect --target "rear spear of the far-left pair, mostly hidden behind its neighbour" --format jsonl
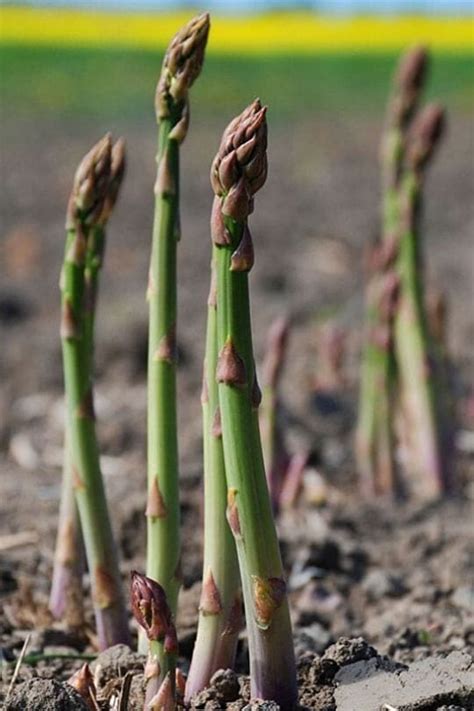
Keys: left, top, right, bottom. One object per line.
{"left": 49, "top": 138, "right": 125, "bottom": 627}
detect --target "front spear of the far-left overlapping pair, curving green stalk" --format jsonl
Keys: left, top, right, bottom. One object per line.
{"left": 61, "top": 135, "right": 130, "bottom": 649}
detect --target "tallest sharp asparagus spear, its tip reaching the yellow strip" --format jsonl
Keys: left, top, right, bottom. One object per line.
{"left": 146, "top": 9, "right": 209, "bottom": 656}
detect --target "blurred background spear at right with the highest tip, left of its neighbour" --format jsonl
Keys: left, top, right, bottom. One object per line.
{"left": 356, "top": 47, "right": 427, "bottom": 495}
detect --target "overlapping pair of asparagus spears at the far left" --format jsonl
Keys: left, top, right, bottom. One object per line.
{"left": 58, "top": 135, "right": 130, "bottom": 649}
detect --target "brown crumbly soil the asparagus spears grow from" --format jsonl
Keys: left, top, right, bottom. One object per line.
{"left": 0, "top": 108, "right": 474, "bottom": 711}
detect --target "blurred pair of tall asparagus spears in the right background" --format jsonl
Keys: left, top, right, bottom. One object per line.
{"left": 356, "top": 48, "right": 447, "bottom": 497}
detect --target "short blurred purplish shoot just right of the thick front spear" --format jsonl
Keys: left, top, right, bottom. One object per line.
{"left": 259, "top": 318, "right": 290, "bottom": 512}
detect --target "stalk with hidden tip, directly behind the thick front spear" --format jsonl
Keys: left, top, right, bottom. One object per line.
{"left": 186, "top": 262, "right": 242, "bottom": 701}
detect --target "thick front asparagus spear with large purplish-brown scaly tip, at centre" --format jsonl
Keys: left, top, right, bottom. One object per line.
{"left": 211, "top": 100, "right": 297, "bottom": 710}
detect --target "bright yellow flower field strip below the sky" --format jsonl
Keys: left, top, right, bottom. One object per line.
{"left": 0, "top": 7, "right": 474, "bottom": 55}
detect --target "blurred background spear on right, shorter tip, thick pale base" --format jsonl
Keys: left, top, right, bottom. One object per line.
{"left": 394, "top": 104, "right": 447, "bottom": 498}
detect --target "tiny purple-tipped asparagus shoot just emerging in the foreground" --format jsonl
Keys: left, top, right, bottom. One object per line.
{"left": 130, "top": 570, "right": 178, "bottom": 711}
